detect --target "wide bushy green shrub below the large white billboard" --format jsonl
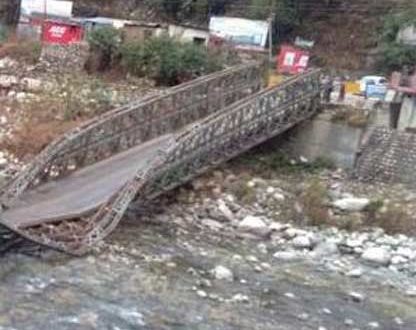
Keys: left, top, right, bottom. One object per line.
{"left": 121, "top": 36, "right": 221, "bottom": 86}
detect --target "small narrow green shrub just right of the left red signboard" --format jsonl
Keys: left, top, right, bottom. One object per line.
{"left": 88, "top": 27, "right": 122, "bottom": 71}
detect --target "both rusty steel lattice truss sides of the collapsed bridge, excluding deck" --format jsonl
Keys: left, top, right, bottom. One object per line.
{"left": 1, "top": 64, "right": 320, "bottom": 255}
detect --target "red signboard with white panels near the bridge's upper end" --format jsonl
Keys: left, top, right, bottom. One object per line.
{"left": 277, "top": 45, "right": 310, "bottom": 74}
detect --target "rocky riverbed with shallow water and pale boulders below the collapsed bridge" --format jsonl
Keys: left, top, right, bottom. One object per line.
{"left": 0, "top": 159, "right": 416, "bottom": 330}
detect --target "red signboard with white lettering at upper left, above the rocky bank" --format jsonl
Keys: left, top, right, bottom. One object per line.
{"left": 42, "top": 21, "right": 83, "bottom": 45}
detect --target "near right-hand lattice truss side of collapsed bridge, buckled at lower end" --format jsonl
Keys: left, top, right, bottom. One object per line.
{"left": 71, "top": 71, "right": 321, "bottom": 253}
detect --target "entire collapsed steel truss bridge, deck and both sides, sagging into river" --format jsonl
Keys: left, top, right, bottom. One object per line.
{"left": 0, "top": 63, "right": 320, "bottom": 255}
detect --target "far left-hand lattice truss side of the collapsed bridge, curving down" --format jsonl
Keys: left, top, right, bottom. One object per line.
{"left": 0, "top": 63, "right": 263, "bottom": 206}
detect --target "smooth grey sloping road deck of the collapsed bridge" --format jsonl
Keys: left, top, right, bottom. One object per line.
{"left": 1, "top": 135, "right": 170, "bottom": 227}
